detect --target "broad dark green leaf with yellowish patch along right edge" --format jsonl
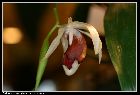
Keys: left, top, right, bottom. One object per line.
{"left": 104, "top": 3, "right": 136, "bottom": 91}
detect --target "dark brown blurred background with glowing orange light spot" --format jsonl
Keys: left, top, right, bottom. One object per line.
{"left": 3, "top": 3, "right": 120, "bottom": 91}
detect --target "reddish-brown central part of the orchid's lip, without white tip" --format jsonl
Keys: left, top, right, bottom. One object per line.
{"left": 63, "top": 36, "right": 87, "bottom": 69}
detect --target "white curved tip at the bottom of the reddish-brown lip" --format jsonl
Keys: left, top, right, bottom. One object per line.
{"left": 62, "top": 60, "right": 80, "bottom": 76}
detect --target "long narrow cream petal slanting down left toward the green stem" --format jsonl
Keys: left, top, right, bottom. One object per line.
{"left": 45, "top": 28, "right": 64, "bottom": 59}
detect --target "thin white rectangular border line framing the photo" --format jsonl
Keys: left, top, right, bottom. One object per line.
{"left": 2, "top": 2, "right": 137, "bottom": 94}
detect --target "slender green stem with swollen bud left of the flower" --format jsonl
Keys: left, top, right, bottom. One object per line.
{"left": 34, "top": 5, "right": 59, "bottom": 90}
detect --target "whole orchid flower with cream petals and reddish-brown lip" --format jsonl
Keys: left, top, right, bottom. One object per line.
{"left": 44, "top": 17, "right": 102, "bottom": 76}
